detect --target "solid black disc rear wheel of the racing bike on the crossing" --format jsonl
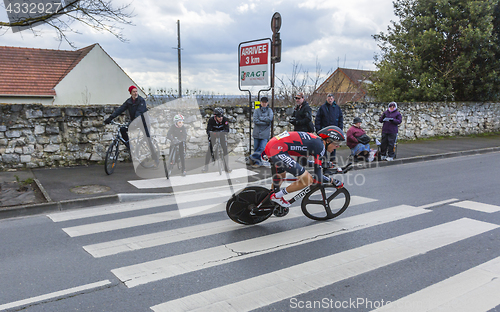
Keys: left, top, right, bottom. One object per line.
{"left": 226, "top": 186, "right": 274, "bottom": 225}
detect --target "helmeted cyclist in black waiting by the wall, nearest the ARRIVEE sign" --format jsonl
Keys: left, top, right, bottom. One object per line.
{"left": 202, "top": 107, "right": 231, "bottom": 173}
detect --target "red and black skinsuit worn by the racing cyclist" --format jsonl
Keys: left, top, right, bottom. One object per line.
{"left": 264, "top": 131, "right": 330, "bottom": 183}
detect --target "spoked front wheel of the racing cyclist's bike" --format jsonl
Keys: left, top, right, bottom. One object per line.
{"left": 301, "top": 185, "right": 351, "bottom": 221}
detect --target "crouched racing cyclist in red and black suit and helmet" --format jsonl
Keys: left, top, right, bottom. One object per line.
{"left": 263, "top": 126, "right": 345, "bottom": 208}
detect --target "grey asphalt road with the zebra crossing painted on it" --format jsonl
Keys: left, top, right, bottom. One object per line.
{"left": 0, "top": 153, "right": 500, "bottom": 312}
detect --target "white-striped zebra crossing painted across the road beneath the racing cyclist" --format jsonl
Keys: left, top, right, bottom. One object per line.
{"left": 44, "top": 185, "right": 500, "bottom": 312}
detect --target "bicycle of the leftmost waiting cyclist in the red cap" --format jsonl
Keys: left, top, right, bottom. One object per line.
{"left": 104, "top": 120, "right": 160, "bottom": 175}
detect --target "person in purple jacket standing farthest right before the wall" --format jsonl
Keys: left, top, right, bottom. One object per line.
{"left": 378, "top": 102, "right": 403, "bottom": 161}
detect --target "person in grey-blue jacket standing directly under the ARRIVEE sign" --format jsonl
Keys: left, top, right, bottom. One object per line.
{"left": 249, "top": 97, "right": 274, "bottom": 167}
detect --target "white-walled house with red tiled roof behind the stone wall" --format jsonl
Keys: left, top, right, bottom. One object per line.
{"left": 0, "top": 43, "right": 146, "bottom": 106}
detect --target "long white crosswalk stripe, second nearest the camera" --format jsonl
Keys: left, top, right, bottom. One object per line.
{"left": 151, "top": 219, "right": 498, "bottom": 312}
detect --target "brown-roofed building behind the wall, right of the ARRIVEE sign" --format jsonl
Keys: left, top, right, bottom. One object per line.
{"left": 315, "top": 67, "right": 373, "bottom": 104}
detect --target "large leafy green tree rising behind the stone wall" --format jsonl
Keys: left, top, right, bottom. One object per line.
{"left": 370, "top": 0, "right": 500, "bottom": 101}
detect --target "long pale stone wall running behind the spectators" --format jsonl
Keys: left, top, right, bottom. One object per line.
{"left": 0, "top": 99, "right": 500, "bottom": 170}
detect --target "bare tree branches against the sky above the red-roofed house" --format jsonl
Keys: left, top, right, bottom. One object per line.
{"left": 0, "top": 0, "right": 133, "bottom": 47}
